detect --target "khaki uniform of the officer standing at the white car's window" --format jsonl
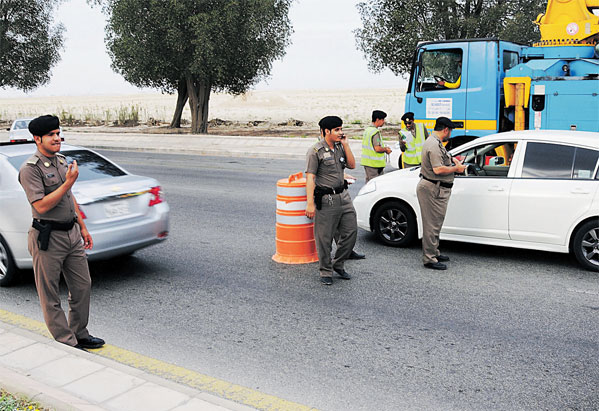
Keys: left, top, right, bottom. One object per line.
{"left": 416, "top": 134, "right": 454, "bottom": 264}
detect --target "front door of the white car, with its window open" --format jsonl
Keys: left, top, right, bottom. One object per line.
{"left": 441, "top": 141, "right": 517, "bottom": 239}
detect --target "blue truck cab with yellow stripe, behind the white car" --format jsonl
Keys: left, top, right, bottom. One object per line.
{"left": 405, "top": 39, "right": 525, "bottom": 146}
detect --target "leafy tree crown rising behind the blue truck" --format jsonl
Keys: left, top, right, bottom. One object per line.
{"left": 354, "top": 0, "right": 546, "bottom": 75}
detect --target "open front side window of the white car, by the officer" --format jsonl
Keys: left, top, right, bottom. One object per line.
{"left": 455, "top": 142, "right": 516, "bottom": 178}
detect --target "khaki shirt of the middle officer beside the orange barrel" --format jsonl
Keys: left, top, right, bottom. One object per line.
{"left": 306, "top": 139, "right": 347, "bottom": 188}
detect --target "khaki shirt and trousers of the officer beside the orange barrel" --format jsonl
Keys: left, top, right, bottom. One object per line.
{"left": 306, "top": 139, "right": 358, "bottom": 277}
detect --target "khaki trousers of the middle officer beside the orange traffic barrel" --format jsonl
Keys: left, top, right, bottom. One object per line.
{"left": 314, "top": 190, "right": 358, "bottom": 277}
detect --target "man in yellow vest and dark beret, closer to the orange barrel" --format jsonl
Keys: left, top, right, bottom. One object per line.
{"left": 360, "top": 110, "right": 391, "bottom": 183}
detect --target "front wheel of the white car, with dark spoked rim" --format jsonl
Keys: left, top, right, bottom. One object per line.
{"left": 372, "top": 201, "right": 416, "bottom": 247}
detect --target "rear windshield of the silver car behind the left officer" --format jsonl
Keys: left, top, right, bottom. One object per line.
{"left": 8, "top": 150, "right": 126, "bottom": 181}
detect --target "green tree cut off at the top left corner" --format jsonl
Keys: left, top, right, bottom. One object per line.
{"left": 0, "top": 0, "right": 64, "bottom": 91}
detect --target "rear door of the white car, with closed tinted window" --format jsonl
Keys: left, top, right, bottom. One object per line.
{"left": 509, "top": 142, "right": 599, "bottom": 245}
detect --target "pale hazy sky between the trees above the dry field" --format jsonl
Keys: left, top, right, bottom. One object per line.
{"left": 0, "top": 0, "right": 406, "bottom": 98}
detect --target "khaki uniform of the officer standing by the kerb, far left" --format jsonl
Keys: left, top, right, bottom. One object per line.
{"left": 19, "top": 150, "right": 91, "bottom": 346}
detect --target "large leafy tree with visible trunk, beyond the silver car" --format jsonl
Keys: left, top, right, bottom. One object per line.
{"left": 104, "top": 0, "right": 293, "bottom": 133}
